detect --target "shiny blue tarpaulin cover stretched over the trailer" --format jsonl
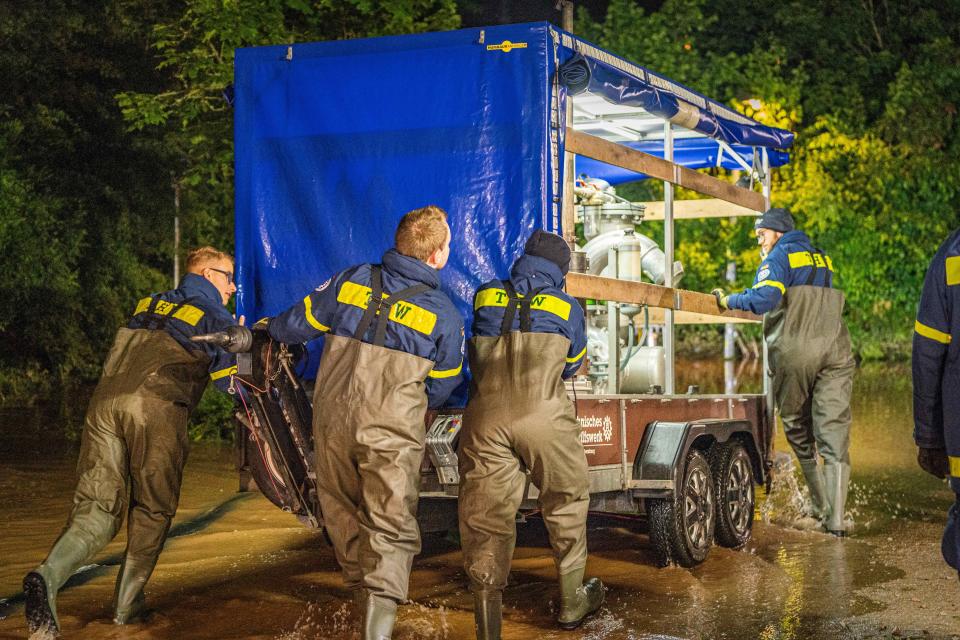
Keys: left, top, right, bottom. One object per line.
{"left": 234, "top": 23, "right": 789, "bottom": 390}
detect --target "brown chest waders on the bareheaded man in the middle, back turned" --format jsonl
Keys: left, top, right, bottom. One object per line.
{"left": 313, "top": 265, "right": 434, "bottom": 639}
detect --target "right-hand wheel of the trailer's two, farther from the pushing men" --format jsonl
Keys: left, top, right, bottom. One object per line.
{"left": 710, "top": 440, "right": 755, "bottom": 549}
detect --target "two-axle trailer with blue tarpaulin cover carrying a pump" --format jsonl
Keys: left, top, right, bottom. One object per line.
{"left": 234, "top": 23, "right": 793, "bottom": 566}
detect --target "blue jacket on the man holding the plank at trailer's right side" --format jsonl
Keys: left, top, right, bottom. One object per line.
{"left": 727, "top": 230, "right": 833, "bottom": 315}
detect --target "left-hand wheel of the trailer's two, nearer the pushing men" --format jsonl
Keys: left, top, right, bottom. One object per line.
{"left": 648, "top": 449, "right": 717, "bottom": 567}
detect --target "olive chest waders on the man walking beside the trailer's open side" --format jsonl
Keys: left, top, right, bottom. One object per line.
{"left": 763, "top": 250, "right": 855, "bottom": 535}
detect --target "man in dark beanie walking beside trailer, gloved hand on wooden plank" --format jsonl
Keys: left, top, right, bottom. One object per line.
{"left": 714, "top": 208, "right": 855, "bottom": 536}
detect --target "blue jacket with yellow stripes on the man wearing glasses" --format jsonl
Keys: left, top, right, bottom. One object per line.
{"left": 127, "top": 273, "right": 237, "bottom": 393}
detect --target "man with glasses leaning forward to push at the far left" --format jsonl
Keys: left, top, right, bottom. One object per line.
{"left": 23, "top": 247, "right": 237, "bottom": 634}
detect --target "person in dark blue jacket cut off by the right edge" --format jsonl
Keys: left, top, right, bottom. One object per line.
{"left": 913, "top": 229, "right": 960, "bottom": 570}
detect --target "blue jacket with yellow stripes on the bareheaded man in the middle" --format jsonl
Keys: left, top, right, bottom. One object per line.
{"left": 267, "top": 249, "right": 463, "bottom": 409}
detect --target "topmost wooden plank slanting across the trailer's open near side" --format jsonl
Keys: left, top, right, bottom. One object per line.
{"left": 566, "top": 128, "right": 767, "bottom": 211}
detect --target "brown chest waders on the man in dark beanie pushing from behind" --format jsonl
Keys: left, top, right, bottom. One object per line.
{"left": 458, "top": 281, "right": 603, "bottom": 639}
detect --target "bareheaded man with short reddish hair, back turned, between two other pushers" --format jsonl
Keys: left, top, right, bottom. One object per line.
{"left": 267, "top": 206, "right": 463, "bottom": 640}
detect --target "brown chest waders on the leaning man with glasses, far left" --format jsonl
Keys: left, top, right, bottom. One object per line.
{"left": 24, "top": 298, "right": 210, "bottom": 628}
